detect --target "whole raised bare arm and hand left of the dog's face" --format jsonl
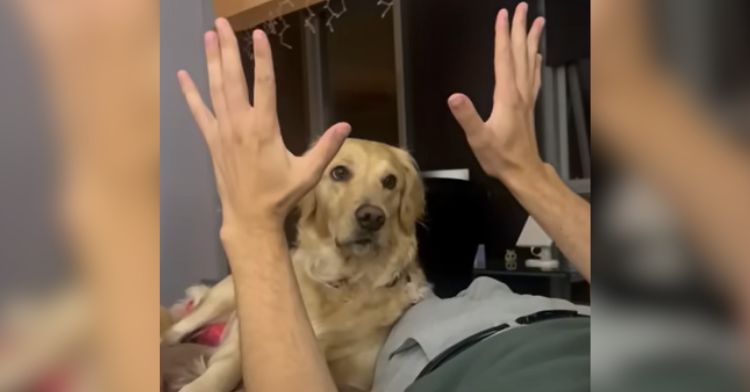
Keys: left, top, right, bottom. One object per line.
{"left": 178, "top": 18, "right": 351, "bottom": 392}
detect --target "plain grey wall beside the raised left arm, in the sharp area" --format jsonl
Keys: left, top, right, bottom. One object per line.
{"left": 161, "top": 0, "right": 227, "bottom": 305}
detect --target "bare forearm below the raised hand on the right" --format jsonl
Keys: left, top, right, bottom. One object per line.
{"left": 503, "top": 164, "right": 591, "bottom": 282}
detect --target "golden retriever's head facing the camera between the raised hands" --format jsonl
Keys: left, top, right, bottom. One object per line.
{"left": 298, "top": 139, "right": 425, "bottom": 258}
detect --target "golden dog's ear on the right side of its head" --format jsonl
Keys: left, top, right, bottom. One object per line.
{"left": 397, "top": 150, "right": 425, "bottom": 234}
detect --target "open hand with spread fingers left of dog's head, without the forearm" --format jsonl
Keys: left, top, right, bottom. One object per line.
{"left": 178, "top": 19, "right": 350, "bottom": 228}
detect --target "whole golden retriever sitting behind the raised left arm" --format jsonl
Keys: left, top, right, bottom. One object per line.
{"left": 162, "top": 139, "right": 429, "bottom": 392}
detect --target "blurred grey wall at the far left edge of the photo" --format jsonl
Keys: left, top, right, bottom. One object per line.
{"left": 0, "top": 1, "right": 65, "bottom": 298}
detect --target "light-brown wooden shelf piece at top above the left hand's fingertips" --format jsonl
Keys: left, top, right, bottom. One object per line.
{"left": 214, "top": 0, "right": 323, "bottom": 31}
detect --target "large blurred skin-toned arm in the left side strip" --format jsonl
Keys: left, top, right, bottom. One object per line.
{"left": 22, "top": 0, "right": 159, "bottom": 392}
